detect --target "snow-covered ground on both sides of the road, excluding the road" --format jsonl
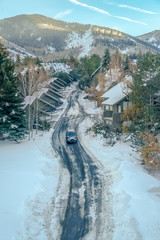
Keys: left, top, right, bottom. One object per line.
{"left": 0, "top": 88, "right": 160, "bottom": 240}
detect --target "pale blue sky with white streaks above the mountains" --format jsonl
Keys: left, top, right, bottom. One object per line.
{"left": 0, "top": 0, "right": 160, "bottom": 36}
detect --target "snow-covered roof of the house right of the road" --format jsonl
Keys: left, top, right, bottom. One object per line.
{"left": 102, "top": 83, "right": 126, "bottom": 105}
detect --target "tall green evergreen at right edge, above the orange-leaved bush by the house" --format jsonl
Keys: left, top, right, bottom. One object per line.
{"left": 127, "top": 53, "right": 160, "bottom": 135}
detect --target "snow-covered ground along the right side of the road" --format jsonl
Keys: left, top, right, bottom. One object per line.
{"left": 79, "top": 92, "right": 160, "bottom": 240}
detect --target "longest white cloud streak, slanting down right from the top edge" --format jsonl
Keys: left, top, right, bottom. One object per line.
{"left": 69, "top": 0, "right": 147, "bottom": 25}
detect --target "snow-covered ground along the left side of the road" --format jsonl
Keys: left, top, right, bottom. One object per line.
{"left": 0, "top": 84, "right": 76, "bottom": 240}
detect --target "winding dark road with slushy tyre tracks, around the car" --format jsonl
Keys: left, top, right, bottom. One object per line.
{"left": 52, "top": 91, "right": 102, "bottom": 240}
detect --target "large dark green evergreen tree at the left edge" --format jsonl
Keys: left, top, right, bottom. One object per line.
{"left": 0, "top": 43, "right": 26, "bottom": 141}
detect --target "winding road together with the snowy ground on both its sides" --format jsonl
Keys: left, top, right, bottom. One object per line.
{"left": 0, "top": 87, "right": 160, "bottom": 240}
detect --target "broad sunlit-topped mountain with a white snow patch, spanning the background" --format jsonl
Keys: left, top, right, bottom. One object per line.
{"left": 0, "top": 14, "right": 160, "bottom": 60}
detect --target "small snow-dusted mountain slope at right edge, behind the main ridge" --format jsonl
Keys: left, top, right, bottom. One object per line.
{"left": 138, "top": 30, "right": 160, "bottom": 49}
